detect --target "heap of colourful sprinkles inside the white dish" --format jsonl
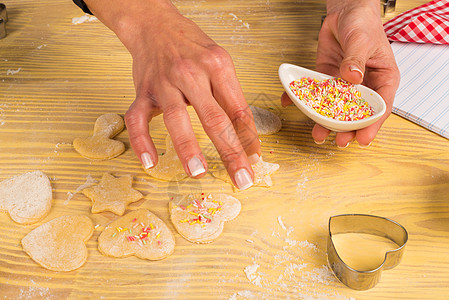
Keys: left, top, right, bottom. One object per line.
{"left": 290, "top": 77, "right": 374, "bottom": 121}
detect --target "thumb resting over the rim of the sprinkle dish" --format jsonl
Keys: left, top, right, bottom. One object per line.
{"left": 340, "top": 33, "right": 370, "bottom": 84}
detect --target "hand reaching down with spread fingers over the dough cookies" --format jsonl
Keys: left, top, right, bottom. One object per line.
{"left": 88, "top": 0, "right": 260, "bottom": 189}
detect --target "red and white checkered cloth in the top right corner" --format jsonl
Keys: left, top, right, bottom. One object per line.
{"left": 384, "top": 0, "right": 449, "bottom": 44}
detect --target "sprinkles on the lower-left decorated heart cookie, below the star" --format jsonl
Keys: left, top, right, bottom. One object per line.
{"left": 112, "top": 218, "right": 162, "bottom": 245}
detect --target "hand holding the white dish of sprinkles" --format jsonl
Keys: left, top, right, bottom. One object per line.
{"left": 281, "top": 0, "right": 400, "bottom": 147}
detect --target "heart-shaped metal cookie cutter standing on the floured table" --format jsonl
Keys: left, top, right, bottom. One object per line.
{"left": 327, "top": 214, "right": 408, "bottom": 290}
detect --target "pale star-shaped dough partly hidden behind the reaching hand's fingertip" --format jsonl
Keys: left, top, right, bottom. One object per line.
{"left": 211, "top": 157, "right": 279, "bottom": 187}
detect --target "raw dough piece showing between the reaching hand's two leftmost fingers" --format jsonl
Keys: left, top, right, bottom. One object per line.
{"left": 144, "top": 135, "right": 188, "bottom": 181}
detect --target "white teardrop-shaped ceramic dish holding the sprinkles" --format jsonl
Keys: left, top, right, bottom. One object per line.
{"left": 279, "top": 64, "right": 387, "bottom": 132}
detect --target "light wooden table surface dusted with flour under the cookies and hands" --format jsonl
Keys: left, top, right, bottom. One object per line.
{"left": 0, "top": 0, "right": 449, "bottom": 299}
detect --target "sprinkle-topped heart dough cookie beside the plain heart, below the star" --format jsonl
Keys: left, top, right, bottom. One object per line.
{"left": 98, "top": 209, "right": 175, "bottom": 260}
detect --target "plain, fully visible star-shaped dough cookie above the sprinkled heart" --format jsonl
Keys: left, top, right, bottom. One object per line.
{"left": 82, "top": 173, "right": 143, "bottom": 216}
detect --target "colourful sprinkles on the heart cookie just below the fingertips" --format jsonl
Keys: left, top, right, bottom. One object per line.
{"left": 175, "top": 193, "right": 223, "bottom": 227}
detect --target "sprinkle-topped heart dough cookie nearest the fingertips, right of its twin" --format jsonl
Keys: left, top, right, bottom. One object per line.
{"left": 169, "top": 194, "right": 242, "bottom": 243}
